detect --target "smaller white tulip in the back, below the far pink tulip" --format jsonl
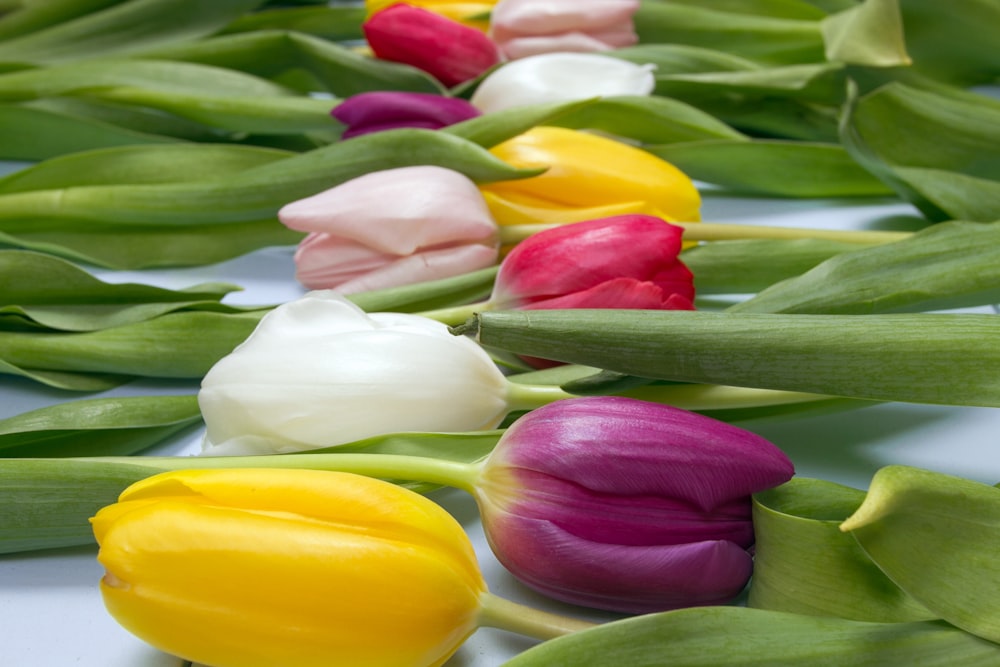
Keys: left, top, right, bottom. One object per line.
{"left": 470, "top": 53, "right": 656, "bottom": 113}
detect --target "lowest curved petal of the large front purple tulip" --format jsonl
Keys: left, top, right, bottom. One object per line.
{"left": 489, "top": 517, "right": 752, "bottom": 613}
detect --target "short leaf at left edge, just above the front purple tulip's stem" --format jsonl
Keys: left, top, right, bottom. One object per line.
{"left": 0, "top": 395, "right": 201, "bottom": 458}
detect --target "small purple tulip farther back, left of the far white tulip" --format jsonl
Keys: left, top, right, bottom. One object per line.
{"left": 330, "top": 90, "right": 480, "bottom": 139}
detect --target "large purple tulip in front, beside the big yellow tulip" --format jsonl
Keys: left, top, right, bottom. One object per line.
{"left": 478, "top": 396, "right": 794, "bottom": 613}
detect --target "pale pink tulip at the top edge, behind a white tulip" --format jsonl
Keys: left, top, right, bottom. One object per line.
{"left": 490, "top": 0, "right": 639, "bottom": 60}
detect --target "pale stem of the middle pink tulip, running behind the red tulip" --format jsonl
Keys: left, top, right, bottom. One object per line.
{"left": 500, "top": 222, "right": 911, "bottom": 245}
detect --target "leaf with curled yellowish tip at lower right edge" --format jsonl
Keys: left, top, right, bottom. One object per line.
{"left": 841, "top": 466, "right": 1000, "bottom": 642}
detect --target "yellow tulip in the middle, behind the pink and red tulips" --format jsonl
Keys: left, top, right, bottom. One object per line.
{"left": 479, "top": 127, "right": 701, "bottom": 225}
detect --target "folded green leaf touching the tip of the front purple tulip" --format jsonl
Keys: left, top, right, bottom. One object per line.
{"left": 747, "top": 478, "right": 938, "bottom": 623}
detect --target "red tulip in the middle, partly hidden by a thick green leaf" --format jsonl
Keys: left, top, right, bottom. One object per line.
{"left": 490, "top": 215, "right": 694, "bottom": 310}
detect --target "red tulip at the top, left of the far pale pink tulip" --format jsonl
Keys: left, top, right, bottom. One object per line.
{"left": 361, "top": 3, "right": 500, "bottom": 86}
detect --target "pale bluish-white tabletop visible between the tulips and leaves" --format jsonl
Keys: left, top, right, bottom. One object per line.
{"left": 0, "top": 188, "right": 1000, "bottom": 667}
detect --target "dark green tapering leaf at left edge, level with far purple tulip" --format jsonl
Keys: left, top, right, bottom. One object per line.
{"left": 0, "top": 104, "right": 178, "bottom": 160}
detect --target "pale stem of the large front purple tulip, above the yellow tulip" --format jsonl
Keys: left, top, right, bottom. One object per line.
{"left": 109, "top": 453, "right": 479, "bottom": 493}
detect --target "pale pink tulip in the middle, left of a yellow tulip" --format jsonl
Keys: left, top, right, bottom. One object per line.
{"left": 278, "top": 165, "right": 498, "bottom": 294}
